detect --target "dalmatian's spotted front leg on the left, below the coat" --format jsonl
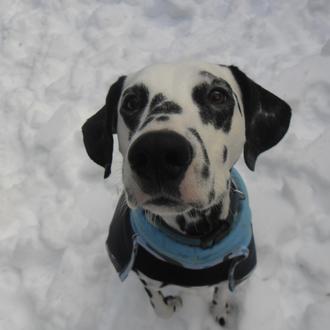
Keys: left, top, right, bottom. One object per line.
{"left": 138, "top": 273, "right": 182, "bottom": 319}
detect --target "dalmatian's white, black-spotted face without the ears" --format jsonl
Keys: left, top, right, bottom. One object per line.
{"left": 117, "top": 64, "right": 245, "bottom": 214}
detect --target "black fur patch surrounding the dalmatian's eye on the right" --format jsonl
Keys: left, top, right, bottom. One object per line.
{"left": 192, "top": 79, "right": 235, "bottom": 133}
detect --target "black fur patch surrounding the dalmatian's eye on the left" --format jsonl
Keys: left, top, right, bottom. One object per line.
{"left": 120, "top": 84, "right": 149, "bottom": 132}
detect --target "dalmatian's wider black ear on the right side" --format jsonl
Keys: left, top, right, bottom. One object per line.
{"left": 229, "top": 66, "right": 291, "bottom": 171}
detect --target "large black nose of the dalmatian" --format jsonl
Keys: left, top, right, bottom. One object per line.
{"left": 128, "top": 130, "right": 193, "bottom": 187}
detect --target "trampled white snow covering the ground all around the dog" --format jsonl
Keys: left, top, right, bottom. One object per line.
{"left": 0, "top": 0, "right": 330, "bottom": 330}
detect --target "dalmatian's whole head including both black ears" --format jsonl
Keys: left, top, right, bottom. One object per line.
{"left": 83, "top": 63, "right": 291, "bottom": 214}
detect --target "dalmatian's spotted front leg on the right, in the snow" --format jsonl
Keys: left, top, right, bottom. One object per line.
{"left": 210, "top": 282, "right": 233, "bottom": 328}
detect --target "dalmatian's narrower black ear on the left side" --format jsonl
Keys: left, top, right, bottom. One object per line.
{"left": 82, "top": 76, "right": 125, "bottom": 178}
